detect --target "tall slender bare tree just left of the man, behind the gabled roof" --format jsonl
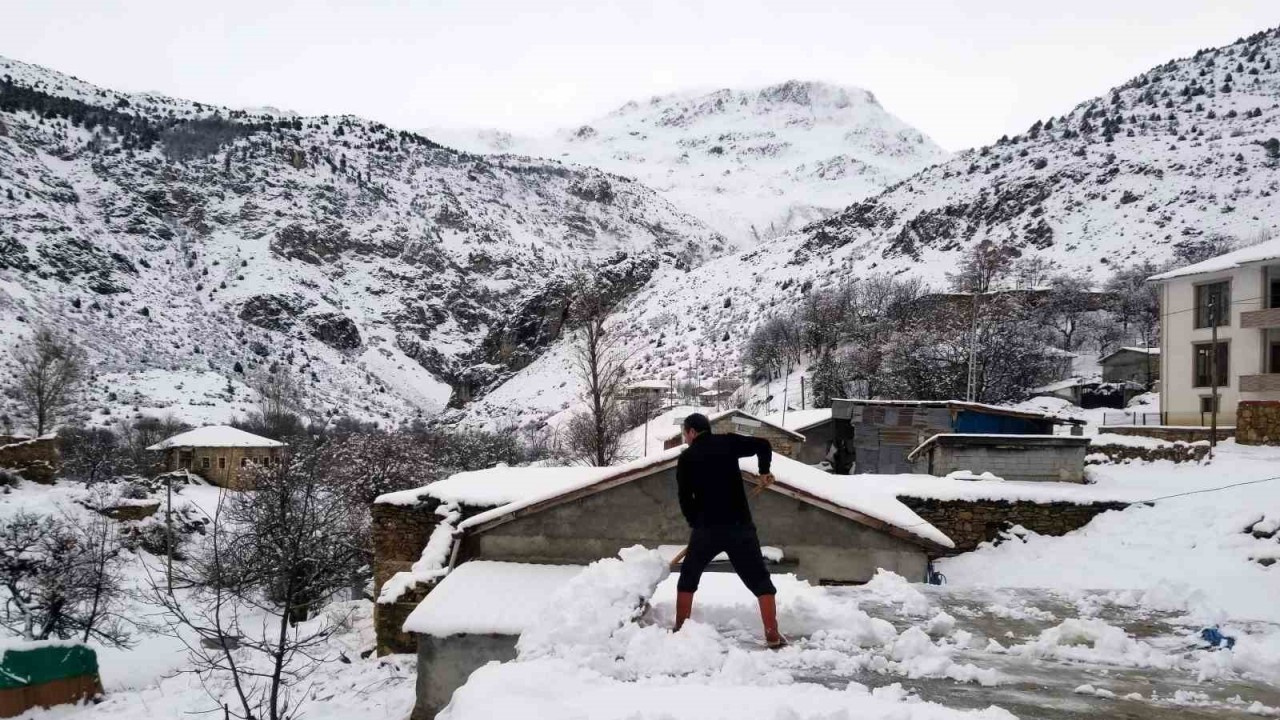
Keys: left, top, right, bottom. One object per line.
{"left": 566, "top": 273, "right": 626, "bottom": 465}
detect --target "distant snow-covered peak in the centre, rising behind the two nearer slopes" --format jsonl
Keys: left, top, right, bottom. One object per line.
{"left": 428, "top": 81, "right": 946, "bottom": 247}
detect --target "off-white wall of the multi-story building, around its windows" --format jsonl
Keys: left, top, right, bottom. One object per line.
{"left": 1160, "top": 265, "right": 1275, "bottom": 425}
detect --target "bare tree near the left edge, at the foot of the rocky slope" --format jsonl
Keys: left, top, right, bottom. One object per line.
{"left": 12, "top": 327, "right": 84, "bottom": 436}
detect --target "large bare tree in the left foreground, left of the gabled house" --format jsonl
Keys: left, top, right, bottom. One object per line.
{"left": 150, "top": 445, "right": 367, "bottom": 720}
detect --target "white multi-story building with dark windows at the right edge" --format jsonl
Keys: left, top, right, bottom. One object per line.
{"left": 1151, "top": 240, "right": 1280, "bottom": 425}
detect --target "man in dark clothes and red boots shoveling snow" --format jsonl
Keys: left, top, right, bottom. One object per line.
{"left": 676, "top": 413, "right": 786, "bottom": 648}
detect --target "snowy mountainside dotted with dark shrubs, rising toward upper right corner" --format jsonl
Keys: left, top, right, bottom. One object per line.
{"left": 462, "top": 29, "right": 1280, "bottom": 424}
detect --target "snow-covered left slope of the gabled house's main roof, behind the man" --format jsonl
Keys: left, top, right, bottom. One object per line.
{"left": 374, "top": 465, "right": 613, "bottom": 507}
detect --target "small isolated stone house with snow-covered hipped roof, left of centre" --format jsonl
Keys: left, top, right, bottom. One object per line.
{"left": 147, "top": 425, "right": 287, "bottom": 489}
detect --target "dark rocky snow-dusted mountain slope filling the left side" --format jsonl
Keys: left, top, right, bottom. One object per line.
{"left": 0, "top": 59, "right": 723, "bottom": 420}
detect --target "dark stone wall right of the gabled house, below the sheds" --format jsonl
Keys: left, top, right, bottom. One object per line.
{"left": 899, "top": 496, "right": 1126, "bottom": 555}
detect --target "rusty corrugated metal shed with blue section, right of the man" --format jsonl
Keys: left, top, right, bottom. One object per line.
{"left": 832, "top": 400, "right": 1084, "bottom": 474}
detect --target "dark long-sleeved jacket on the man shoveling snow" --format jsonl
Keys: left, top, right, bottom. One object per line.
{"left": 676, "top": 433, "right": 773, "bottom": 528}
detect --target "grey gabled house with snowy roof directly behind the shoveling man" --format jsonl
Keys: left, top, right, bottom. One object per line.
{"left": 374, "top": 446, "right": 954, "bottom": 720}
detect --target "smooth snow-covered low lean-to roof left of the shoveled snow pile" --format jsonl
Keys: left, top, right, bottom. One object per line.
{"left": 403, "top": 560, "right": 582, "bottom": 638}
